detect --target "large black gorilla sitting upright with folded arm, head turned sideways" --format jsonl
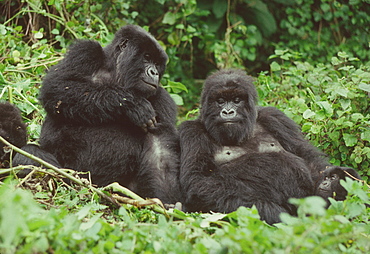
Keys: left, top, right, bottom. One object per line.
{"left": 40, "top": 25, "right": 180, "bottom": 203}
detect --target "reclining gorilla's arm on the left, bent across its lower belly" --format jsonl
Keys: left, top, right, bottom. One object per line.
{"left": 179, "top": 120, "right": 289, "bottom": 224}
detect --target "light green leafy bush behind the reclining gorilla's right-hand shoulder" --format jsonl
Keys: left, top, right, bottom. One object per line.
{"left": 257, "top": 50, "right": 370, "bottom": 179}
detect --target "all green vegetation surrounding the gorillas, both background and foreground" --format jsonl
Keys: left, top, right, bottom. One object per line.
{"left": 0, "top": 0, "right": 370, "bottom": 253}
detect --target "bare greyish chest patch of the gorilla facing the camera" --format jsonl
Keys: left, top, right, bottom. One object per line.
{"left": 214, "top": 136, "right": 285, "bottom": 164}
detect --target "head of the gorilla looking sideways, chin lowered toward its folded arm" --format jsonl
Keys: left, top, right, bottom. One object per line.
{"left": 104, "top": 25, "right": 168, "bottom": 97}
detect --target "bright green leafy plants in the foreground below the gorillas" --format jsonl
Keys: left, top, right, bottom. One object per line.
{"left": 0, "top": 179, "right": 370, "bottom": 254}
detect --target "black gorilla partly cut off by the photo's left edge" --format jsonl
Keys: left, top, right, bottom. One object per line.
{"left": 0, "top": 102, "right": 27, "bottom": 168}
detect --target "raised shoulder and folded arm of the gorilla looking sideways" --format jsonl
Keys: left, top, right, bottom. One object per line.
{"left": 40, "top": 40, "right": 155, "bottom": 126}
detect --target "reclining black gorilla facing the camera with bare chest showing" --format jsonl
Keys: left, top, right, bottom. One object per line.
{"left": 179, "top": 70, "right": 362, "bottom": 224}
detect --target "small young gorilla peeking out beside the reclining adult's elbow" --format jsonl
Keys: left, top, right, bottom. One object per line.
{"left": 316, "top": 166, "right": 361, "bottom": 205}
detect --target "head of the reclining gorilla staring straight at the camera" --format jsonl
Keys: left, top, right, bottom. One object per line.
{"left": 200, "top": 70, "right": 257, "bottom": 146}
